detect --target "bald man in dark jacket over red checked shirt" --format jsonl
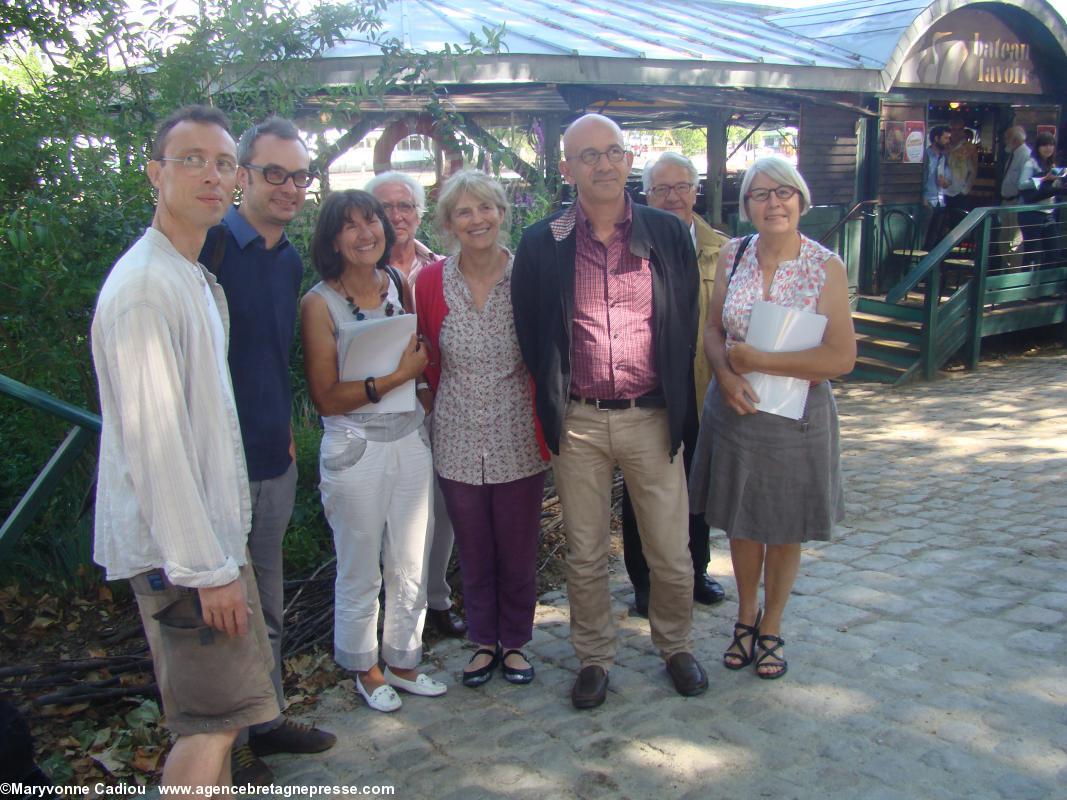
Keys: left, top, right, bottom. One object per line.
{"left": 511, "top": 114, "right": 707, "bottom": 708}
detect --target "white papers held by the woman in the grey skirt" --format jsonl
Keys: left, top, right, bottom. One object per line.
{"left": 745, "top": 300, "right": 826, "bottom": 419}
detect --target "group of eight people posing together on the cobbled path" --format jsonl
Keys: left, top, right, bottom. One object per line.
{"left": 92, "top": 107, "right": 856, "bottom": 785}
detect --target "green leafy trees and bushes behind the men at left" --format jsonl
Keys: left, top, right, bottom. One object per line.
{"left": 0, "top": 0, "right": 498, "bottom": 580}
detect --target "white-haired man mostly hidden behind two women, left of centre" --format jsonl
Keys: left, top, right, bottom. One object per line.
{"left": 364, "top": 172, "right": 466, "bottom": 638}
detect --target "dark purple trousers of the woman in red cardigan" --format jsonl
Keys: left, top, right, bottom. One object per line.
{"left": 440, "top": 473, "right": 544, "bottom": 650}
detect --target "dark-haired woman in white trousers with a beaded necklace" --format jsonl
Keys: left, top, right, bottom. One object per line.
{"left": 300, "top": 190, "right": 447, "bottom": 711}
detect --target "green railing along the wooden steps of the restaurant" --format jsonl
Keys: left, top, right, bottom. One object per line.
{"left": 886, "top": 203, "right": 1067, "bottom": 380}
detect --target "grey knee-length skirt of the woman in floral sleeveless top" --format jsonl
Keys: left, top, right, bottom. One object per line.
{"left": 689, "top": 381, "right": 845, "bottom": 544}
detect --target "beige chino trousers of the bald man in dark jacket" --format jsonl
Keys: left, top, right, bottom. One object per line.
{"left": 552, "top": 400, "right": 692, "bottom": 670}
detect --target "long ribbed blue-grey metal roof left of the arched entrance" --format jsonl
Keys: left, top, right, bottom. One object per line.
{"left": 325, "top": 0, "right": 878, "bottom": 68}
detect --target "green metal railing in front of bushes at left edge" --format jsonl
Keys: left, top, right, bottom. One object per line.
{"left": 0, "top": 375, "right": 100, "bottom": 557}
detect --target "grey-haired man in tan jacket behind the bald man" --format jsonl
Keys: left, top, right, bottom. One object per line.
{"left": 622, "top": 153, "right": 729, "bottom": 617}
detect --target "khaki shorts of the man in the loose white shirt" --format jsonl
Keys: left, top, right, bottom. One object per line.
{"left": 130, "top": 565, "right": 280, "bottom": 736}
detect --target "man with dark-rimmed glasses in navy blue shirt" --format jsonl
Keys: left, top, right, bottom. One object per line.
{"left": 201, "top": 117, "right": 336, "bottom": 785}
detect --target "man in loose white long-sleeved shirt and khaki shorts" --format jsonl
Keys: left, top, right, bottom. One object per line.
{"left": 92, "top": 106, "right": 278, "bottom": 791}
